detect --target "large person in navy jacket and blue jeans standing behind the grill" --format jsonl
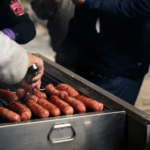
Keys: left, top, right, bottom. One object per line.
{"left": 52, "top": 0, "right": 150, "bottom": 105}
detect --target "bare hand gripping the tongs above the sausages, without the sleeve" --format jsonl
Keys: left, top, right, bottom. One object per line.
{"left": 20, "top": 52, "right": 44, "bottom": 90}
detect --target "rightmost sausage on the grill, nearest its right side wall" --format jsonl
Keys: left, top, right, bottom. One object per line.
{"left": 76, "top": 95, "right": 104, "bottom": 111}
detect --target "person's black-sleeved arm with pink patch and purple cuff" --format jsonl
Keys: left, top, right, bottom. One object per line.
{"left": 0, "top": 0, "right": 36, "bottom": 44}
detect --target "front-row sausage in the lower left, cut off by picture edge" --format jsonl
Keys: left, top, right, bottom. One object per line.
{"left": 0, "top": 107, "right": 20, "bottom": 122}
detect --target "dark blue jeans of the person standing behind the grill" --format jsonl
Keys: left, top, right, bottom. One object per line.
{"left": 81, "top": 74, "right": 144, "bottom": 105}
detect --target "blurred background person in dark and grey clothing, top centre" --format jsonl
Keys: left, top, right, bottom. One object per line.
{"left": 31, "top": 0, "right": 75, "bottom": 53}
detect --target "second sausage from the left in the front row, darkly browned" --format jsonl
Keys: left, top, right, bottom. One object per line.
{"left": 9, "top": 101, "right": 32, "bottom": 121}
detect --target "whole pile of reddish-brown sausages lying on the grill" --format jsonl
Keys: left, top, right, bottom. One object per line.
{"left": 0, "top": 83, "right": 104, "bottom": 122}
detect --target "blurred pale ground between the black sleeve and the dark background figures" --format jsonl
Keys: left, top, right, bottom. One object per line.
{"left": 18, "top": 0, "right": 56, "bottom": 61}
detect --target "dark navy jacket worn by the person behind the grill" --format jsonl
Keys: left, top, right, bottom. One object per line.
{"left": 66, "top": 0, "right": 150, "bottom": 78}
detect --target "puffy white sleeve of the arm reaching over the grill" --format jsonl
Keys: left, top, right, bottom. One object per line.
{"left": 0, "top": 31, "right": 29, "bottom": 84}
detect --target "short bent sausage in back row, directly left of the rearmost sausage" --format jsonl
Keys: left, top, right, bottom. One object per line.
{"left": 45, "top": 84, "right": 68, "bottom": 99}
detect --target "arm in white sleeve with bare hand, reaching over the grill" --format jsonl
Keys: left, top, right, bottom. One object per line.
{"left": 0, "top": 32, "right": 44, "bottom": 89}
